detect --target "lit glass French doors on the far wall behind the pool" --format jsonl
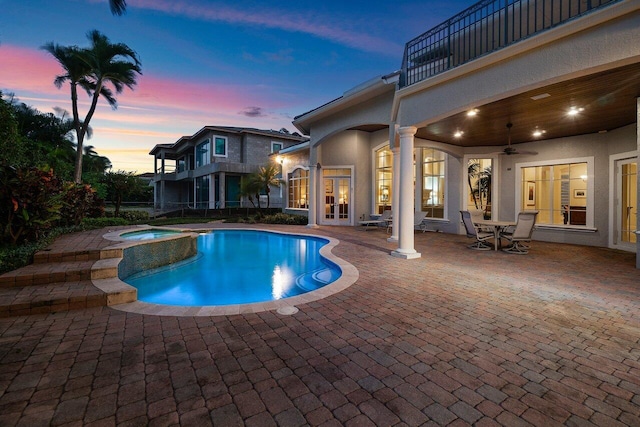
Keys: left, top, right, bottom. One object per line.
{"left": 321, "top": 169, "right": 351, "bottom": 225}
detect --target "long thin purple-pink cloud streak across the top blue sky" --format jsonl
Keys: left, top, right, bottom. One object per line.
{"left": 130, "top": 0, "right": 402, "bottom": 56}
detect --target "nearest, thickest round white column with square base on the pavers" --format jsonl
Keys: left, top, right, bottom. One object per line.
{"left": 391, "top": 126, "right": 422, "bottom": 259}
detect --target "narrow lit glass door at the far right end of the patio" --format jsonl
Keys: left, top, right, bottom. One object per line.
{"left": 614, "top": 159, "right": 638, "bottom": 252}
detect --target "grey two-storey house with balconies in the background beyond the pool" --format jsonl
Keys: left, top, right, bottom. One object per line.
{"left": 149, "top": 126, "right": 307, "bottom": 210}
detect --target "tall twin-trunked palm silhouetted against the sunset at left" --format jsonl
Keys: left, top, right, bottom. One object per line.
{"left": 42, "top": 30, "right": 142, "bottom": 184}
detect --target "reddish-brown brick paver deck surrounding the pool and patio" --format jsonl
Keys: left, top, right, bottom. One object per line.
{"left": 0, "top": 226, "right": 640, "bottom": 427}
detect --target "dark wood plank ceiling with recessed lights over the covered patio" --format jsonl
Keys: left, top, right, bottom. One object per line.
{"left": 416, "top": 63, "right": 640, "bottom": 147}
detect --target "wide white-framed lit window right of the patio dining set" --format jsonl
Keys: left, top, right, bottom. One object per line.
{"left": 519, "top": 161, "right": 593, "bottom": 227}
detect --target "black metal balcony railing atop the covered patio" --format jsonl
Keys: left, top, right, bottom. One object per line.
{"left": 400, "top": 0, "right": 621, "bottom": 87}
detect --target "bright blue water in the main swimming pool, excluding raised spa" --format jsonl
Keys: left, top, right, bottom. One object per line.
{"left": 125, "top": 230, "right": 341, "bottom": 306}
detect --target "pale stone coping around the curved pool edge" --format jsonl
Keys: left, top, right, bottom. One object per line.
{"left": 92, "top": 226, "right": 360, "bottom": 316}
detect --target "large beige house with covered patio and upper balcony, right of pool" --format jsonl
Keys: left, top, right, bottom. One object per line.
{"left": 281, "top": 0, "right": 640, "bottom": 268}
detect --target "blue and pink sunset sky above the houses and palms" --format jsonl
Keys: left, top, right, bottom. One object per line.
{"left": 0, "top": 0, "right": 475, "bottom": 173}
